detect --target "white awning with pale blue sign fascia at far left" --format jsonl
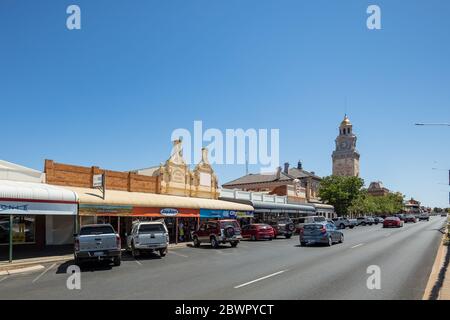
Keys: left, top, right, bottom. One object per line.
{"left": 0, "top": 180, "right": 78, "bottom": 215}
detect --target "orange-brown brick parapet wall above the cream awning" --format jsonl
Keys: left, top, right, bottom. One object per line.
{"left": 44, "top": 160, "right": 159, "bottom": 193}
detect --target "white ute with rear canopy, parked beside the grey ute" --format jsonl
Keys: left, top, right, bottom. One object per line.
{"left": 127, "top": 221, "right": 169, "bottom": 257}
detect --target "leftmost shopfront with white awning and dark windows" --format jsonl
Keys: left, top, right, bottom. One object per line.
{"left": 0, "top": 180, "right": 78, "bottom": 260}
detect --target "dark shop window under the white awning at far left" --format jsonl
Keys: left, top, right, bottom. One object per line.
{"left": 0, "top": 216, "right": 36, "bottom": 244}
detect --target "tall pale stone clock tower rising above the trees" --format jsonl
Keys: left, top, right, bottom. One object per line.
{"left": 332, "top": 115, "right": 360, "bottom": 177}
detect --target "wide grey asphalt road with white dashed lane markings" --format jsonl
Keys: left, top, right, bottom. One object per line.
{"left": 0, "top": 217, "right": 445, "bottom": 300}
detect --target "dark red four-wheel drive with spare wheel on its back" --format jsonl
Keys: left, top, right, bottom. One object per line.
{"left": 192, "top": 219, "right": 242, "bottom": 248}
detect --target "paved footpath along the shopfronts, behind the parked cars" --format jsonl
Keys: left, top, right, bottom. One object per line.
{"left": 0, "top": 242, "right": 191, "bottom": 275}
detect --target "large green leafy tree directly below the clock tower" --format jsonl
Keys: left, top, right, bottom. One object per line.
{"left": 319, "top": 176, "right": 364, "bottom": 216}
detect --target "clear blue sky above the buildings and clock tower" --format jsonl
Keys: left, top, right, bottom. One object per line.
{"left": 0, "top": 0, "right": 450, "bottom": 206}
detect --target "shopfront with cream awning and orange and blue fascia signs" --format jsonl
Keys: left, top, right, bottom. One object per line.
{"left": 66, "top": 187, "right": 253, "bottom": 243}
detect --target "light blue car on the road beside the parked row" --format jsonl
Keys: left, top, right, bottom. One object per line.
{"left": 300, "top": 222, "right": 344, "bottom": 247}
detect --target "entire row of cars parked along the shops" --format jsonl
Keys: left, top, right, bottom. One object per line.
{"left": 74, "top": 213, "right": 436, "bottom": 266}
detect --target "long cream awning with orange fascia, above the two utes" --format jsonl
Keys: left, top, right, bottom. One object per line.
{"left": 64, "top": 187, "right": 253, "bottom": 217}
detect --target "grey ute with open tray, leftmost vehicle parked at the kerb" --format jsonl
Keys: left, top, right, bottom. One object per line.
{"left": 74, "top": 224, "right": 122, "bottom": 266}
